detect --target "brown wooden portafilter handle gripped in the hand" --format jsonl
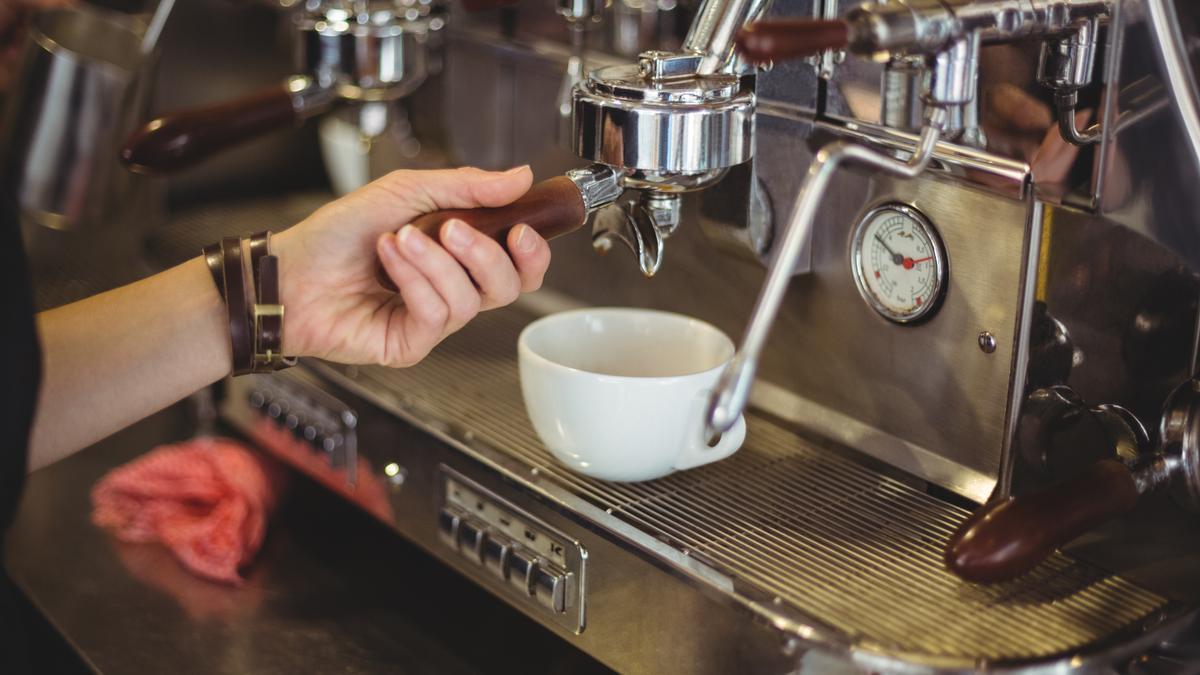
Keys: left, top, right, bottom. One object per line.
{"left": 378, "top": 175, "right": 588, "bottom": 289}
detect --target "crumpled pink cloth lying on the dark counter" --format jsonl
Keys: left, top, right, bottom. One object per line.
{"left": 91, "top": 438, "right": 282, "bottom": 585}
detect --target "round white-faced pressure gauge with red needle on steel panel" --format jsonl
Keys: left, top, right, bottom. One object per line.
{"left": 850, "top": 204, "right": 947, "bottom": 323}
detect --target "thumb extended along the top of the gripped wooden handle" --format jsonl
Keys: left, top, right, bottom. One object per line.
{"left": 374, "top": 166, "right": 533, "bottom": 214}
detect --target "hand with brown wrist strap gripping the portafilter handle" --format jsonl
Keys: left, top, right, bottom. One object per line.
{"left": 272, "top": 167, "right": 550, "bottom": 368}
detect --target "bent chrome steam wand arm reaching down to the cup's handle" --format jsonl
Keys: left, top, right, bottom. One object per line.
{"left": 706, "top": 106, "right": 947, "bottom": 436}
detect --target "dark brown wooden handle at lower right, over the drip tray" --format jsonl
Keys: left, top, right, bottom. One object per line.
{"left": 946, "top": 460, "right": 1139, "bottom": 584}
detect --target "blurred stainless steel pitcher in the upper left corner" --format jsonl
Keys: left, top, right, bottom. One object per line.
{"left": 2, "top": 7, "right": 157, "bottom": 229}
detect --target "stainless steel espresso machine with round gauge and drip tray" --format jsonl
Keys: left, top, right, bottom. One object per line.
{"left": 211, "top": 0, "right": 1200, "bottom": 673}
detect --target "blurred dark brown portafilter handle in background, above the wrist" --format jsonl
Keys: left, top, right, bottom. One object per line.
{"left": 121, "top": 86, "right": 296, "bottom": 173}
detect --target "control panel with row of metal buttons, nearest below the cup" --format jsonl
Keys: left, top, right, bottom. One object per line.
{"left": 438, "top": 466, "right": 587, "bottom": 633}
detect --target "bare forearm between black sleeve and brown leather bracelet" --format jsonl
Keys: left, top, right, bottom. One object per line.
{"left": 30, "top": 253, "right": 232, "bottom": 470}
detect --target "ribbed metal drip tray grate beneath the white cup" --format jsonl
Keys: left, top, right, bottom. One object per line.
{"left": 340, "top": 311, "right": 1169, "bottom": 663}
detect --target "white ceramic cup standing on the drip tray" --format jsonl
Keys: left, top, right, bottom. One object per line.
{"left": 517, "top": 307, "right": 746, "bottom": 480}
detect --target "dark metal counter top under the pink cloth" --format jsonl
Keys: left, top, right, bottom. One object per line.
{"left": 6, "top": 406, "right": 606, "bottom": 675}
